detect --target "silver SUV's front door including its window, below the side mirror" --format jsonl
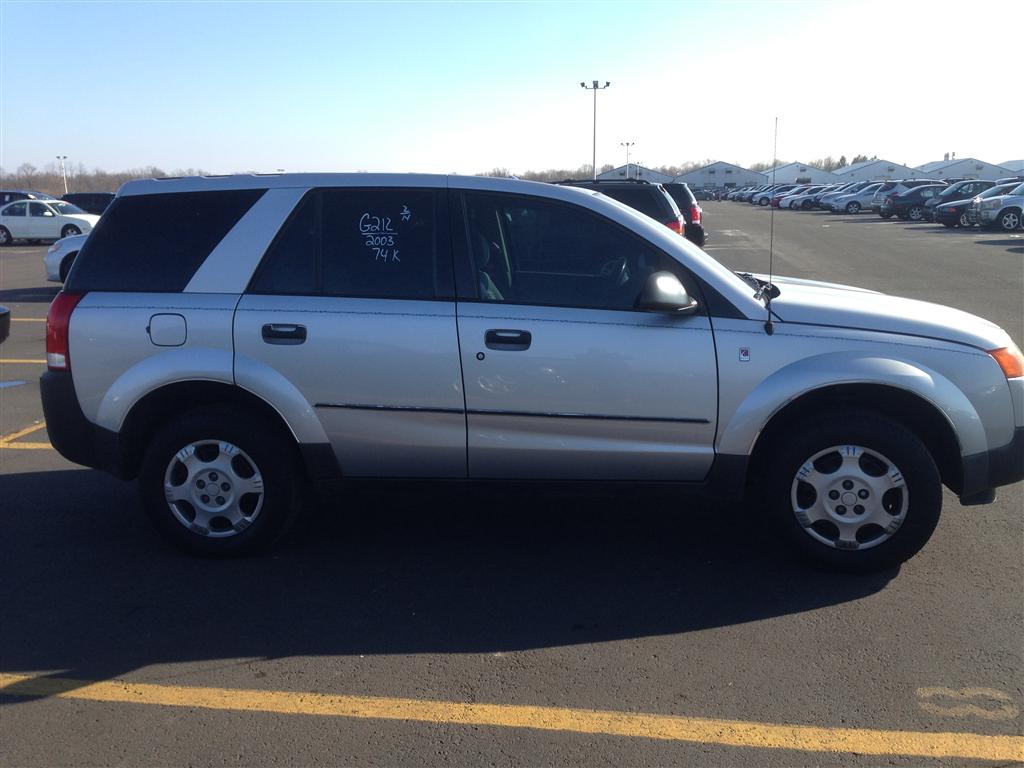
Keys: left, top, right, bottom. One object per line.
{"left": 454, "top": 193, "right": 718, "bottom": 480}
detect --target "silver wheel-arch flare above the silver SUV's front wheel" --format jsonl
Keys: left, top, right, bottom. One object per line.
{"left": 716, "top": 352, "right": 988, "bottom": 456}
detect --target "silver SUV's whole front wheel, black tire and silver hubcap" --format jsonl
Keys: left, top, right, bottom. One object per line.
{"left": 763, "top": 411, "right": 942, "bottom": 571}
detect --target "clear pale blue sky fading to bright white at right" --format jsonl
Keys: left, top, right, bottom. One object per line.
{"left": 0, "top": 0, "right": 1024, "bottom": 173}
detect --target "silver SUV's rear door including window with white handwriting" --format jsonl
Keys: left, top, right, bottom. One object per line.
{"left": 234, "top": 188, "right": 466, "bottom": 477}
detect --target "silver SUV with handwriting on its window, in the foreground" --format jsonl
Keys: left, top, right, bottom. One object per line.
{"left": 41, "top": 174, "right": 1024, "bottom": 570}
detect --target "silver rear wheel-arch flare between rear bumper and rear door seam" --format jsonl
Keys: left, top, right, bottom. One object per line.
{"left": 96, "top": 347, "right": 232, "bottom": 432}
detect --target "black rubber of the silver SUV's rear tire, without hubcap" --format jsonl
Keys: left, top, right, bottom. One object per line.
{"left": 139, "top": 406, "right": 304, "bottom": 557}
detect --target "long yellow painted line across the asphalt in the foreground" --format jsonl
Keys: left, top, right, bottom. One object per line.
{"left": 0, "top": 674, "right": 1024, "bottom": 761}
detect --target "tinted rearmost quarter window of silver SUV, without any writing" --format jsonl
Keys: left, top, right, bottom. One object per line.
{"left": 67, "top": 189, "right": 264, "bottom": 293}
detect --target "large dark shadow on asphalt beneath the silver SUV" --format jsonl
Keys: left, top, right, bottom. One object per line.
{"left": 0, "top": 470, "right": 895, "bottom": 702}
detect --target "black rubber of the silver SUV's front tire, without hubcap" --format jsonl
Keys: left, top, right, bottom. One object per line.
{"left": 761, "top": 411, "right": 942, "bottom": 572}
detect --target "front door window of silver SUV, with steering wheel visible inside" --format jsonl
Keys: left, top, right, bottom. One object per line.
{"left": 466, "top": 194, "right": 683, "bottom": 309}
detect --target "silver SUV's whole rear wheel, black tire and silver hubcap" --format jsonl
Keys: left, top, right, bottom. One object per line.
{"left": 139, "top": 407, "right": 304, "bottom": 556}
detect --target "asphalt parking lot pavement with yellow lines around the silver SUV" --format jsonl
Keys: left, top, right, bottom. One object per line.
{"left": 0, "top": 202, "right": 1024, "bottom": 766}
